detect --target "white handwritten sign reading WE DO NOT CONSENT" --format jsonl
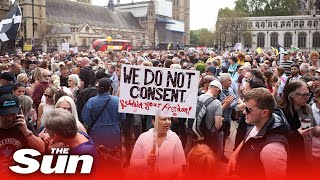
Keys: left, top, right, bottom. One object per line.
{"left": 119, "top": 64, "right": 199, "bottom": 118}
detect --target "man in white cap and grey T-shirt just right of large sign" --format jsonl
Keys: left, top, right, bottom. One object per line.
{"left": 185, "top": 80, "right": 223, "bottom": 159}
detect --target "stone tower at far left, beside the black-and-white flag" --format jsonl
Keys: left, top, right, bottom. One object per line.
{"left": 16, "top": 0, "right": 47, "bottom": 46}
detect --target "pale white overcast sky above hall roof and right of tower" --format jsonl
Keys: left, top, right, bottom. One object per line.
{"left": 92, "top": 0, "right": 235, "bottom": 30}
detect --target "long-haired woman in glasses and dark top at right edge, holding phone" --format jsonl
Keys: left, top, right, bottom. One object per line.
{"left": 279, "top": 80, "right": 320, "bottom": 177}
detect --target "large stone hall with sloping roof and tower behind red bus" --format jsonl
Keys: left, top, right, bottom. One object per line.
{"left": 0, "top": 0, "right": 190, "bottom": 51}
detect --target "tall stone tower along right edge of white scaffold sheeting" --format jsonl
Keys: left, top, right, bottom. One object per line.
{"left": 169, "top": 0, "right": 190, "bottom": 44}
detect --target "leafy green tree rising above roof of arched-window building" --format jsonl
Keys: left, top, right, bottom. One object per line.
{"left": 235, "top": 0, "right": 298, "bottom": 16}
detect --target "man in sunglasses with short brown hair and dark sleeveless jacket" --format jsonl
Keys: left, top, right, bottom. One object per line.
{"left": 227, "top": 88, "right": 288, "bottom": 179}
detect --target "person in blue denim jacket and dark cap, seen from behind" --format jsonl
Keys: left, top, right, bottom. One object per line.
{"left": 81, "top": 78, "right": 125, "bottom": 149}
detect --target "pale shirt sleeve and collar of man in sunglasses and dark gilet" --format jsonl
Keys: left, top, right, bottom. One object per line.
{"left": 246, "top": 126, "right": 288, "bottom": 180}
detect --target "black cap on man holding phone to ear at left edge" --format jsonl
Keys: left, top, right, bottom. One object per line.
{"left": 0, "top": 94, "right": 20, "bottom": 115}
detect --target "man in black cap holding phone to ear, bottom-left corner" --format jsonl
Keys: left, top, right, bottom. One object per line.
{"left": 0, "top": 94, "right": 45, "bottom": 169}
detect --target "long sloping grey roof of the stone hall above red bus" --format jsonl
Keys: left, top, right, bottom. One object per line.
{"left": 46, "top": 0, "right": 142, "bottom": 29}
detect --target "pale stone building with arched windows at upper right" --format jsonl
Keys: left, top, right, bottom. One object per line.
{"left": 241, "top": 15, "right": 320, "bottom": 51}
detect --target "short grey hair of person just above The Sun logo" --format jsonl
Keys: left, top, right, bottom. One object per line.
{"left": 44, "top": 108, "right": 78, "bottom": 139}
